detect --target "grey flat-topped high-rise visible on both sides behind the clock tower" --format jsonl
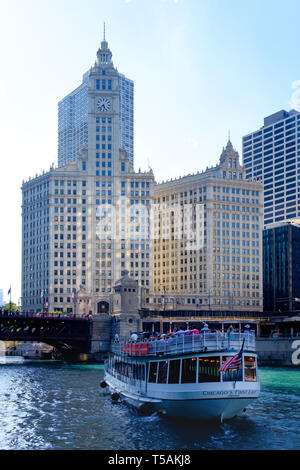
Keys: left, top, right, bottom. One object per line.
{"left": 58, "top": 34, "right": 134, "bottom": 166}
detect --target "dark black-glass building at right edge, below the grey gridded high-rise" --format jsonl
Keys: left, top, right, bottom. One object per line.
{"left": 263, "top": 218, "right": 300, "bottom": 312}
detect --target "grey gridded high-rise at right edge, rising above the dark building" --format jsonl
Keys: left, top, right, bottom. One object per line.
{"left": 243, "top": 110, "right": 300, "bottom": 226}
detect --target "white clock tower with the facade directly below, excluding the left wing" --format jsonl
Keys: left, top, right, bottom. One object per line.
{"left": 85, "top": 29, "right": 154, "bottom": 314}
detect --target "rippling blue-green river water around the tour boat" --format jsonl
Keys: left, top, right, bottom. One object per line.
{"left": 0, "top": 360, "right": 300, "bottom": 450}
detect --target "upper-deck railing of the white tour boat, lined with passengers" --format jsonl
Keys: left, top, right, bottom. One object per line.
{"left": 111, "top": 331, "right": 255, "bottom": 356}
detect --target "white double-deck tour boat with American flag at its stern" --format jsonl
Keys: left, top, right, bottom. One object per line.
{"left": 101, "top": 331, "right": 260, "bottom": 421}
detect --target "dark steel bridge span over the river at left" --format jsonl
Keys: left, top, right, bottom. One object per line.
{"left": 0, "top": 313, "right": 111, "bottom": 361}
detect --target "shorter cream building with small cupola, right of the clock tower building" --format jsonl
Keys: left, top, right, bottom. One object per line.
{"left": 152, "top": 141, "right": 263, "bottom": 311}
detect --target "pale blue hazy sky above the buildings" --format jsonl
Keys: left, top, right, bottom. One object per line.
{"left": 0, "top": 0, "right": 300, "bottom": 303}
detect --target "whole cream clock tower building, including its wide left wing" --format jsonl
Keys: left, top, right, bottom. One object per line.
{"left": 22, "top": 35, "right": 154, "bottom": 313}
